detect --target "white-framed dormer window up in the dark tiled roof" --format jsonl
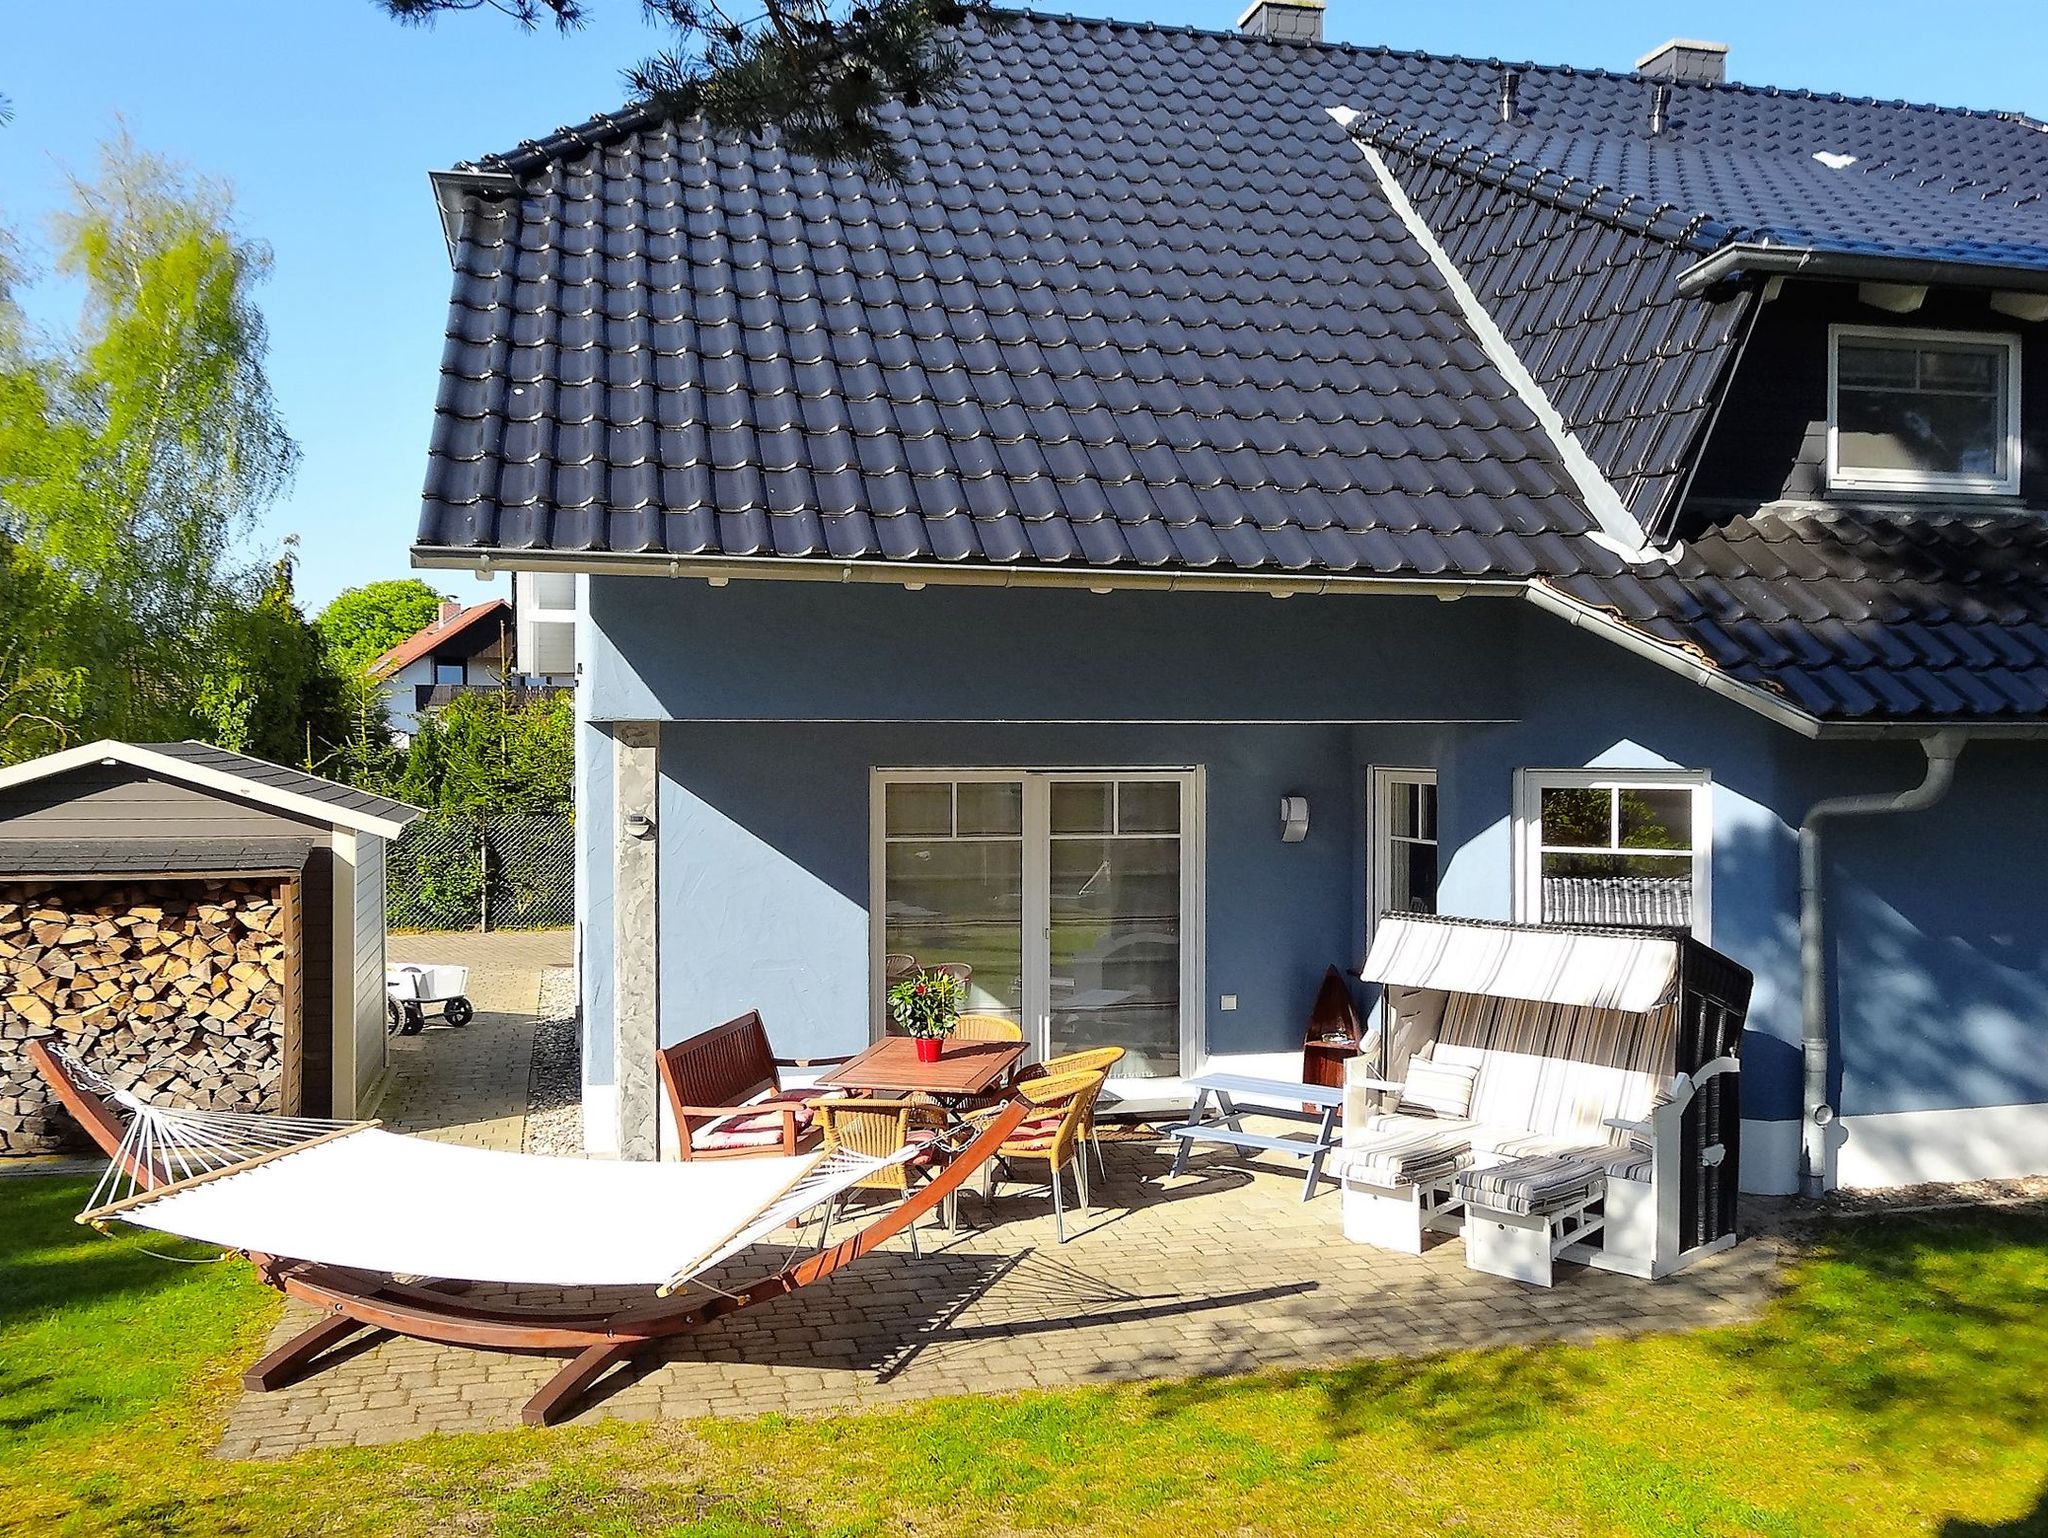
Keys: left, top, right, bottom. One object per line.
{"left": 1827, "top": 326, "right": 2019, "bottom": 496}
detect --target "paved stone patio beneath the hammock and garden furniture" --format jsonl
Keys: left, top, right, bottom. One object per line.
{"left": 219, "top": 1097, "right": 1778, "bottom": 1456}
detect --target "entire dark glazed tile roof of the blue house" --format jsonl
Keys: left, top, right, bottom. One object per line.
{"left": 416, "top": 16, "right": 2048, "bottom": 719}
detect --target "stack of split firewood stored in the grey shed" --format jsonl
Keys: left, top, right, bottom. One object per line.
{"left": 0, "top": 881, "right": 297, "bottom": 1153}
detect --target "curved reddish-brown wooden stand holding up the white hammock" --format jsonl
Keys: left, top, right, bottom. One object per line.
{"left": 29, "top": 1040, "right": 1032, "bottom": 1425}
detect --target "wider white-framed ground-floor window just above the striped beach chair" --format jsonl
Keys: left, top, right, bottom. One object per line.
{"left": 1516, "top": 770, "right": 1714, "bottom": 940}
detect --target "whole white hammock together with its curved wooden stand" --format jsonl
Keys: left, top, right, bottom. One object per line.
{"left": 29, "top": 1040, "right": 1030, "bottom": 1425}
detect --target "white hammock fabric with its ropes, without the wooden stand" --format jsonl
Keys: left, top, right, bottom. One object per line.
{"left": 80, "top": 1085, "right": 913, "bottom": 1292}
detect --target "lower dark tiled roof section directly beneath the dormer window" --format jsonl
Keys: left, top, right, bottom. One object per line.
{"left": 1552, "top": 506, "right": 2048, "bottom": 721}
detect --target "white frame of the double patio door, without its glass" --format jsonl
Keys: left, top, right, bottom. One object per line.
{"left": 868, "top": 764, "right": 1208, "bottom": 1092}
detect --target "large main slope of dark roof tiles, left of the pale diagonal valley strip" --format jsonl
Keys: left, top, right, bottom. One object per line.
{"left": 422, "top": 20, "right": 1671, "bottom": 575}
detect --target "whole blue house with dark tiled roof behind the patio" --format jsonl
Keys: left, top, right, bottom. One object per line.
{"left": 414, "top": 4, "right": 2048, "bottom": 1190}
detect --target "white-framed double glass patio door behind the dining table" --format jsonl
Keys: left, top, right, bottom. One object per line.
{"left": 872, "top": 770, "right": 1200, "bottom": 1079}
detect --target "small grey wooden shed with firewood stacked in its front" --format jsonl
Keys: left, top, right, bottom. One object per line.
{"left": 0, "top": 741, "right": 418, "bottom": 1153}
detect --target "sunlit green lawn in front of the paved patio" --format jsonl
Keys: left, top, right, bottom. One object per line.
{"left": 0, "top": 1180, "right": 2048, "bottom": 1538}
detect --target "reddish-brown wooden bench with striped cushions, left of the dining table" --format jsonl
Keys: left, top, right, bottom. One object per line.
{"left": 655, "top": 1010, "right": 846, "bottom": 1159}
